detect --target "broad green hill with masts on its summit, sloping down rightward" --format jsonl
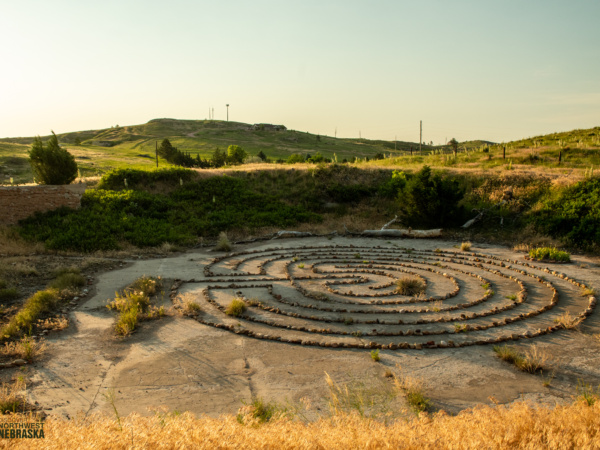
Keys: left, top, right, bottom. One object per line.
{"left": 0, "top": 119, "right": 431, "bottom": 183}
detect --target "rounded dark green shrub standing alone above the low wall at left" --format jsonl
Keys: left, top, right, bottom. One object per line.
{"left": 29, "top": 131, "right": 77, "bottom": 184}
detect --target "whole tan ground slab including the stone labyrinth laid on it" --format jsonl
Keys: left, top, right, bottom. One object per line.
{"left": 9, "top": 237, "right": 600, "bottom": 417}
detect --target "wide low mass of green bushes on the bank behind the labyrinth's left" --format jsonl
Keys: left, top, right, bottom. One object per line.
{"left": 20, "top": 172, "right": 321, "bottom": 252}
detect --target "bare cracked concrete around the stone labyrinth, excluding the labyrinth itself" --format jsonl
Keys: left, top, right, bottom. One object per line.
{"left": 28, "top": 238, "right": 600, "bottom": 417}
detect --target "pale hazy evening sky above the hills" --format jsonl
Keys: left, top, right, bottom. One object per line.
{"left": 0, "top": 0, "right": 600, "bottom": 143}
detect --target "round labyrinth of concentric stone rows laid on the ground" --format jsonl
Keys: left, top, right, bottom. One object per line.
{"left": 171, "top": 244, "right": 596, "bottom": 350}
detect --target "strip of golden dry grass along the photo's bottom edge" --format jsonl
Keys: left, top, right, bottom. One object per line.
{"left": 0, "top": 402, "right": 600, "bottom": 449}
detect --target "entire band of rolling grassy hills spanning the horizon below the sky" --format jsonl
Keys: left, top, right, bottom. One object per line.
{"left": 0, "top": 119, "right": 600, "bottom": 184}
